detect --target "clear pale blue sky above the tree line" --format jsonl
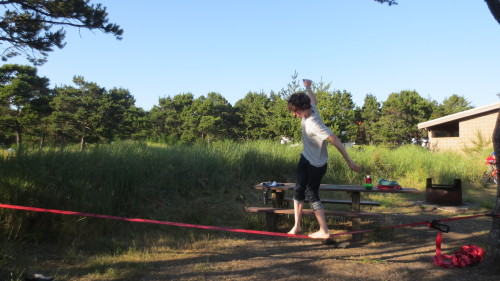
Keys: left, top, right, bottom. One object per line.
{"left": 13, "top": 0, "right": 500, "bottom": 110}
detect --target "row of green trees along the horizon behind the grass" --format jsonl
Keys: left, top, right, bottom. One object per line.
{"left": 0, "top": 64, "right": 472, "bottom": 150}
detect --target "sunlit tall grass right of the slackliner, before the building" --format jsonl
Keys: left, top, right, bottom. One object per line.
{"left": 336, "top": 145, "right": 491, "bottom": 186}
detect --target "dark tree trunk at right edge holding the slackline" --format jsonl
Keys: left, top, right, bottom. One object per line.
{"left": 484, "top": 109, "right": 500, "bottom": 274}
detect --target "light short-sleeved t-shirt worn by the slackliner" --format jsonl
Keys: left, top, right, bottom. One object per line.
{"left": 301, "top": 104, "right": 333, "bottom": 167}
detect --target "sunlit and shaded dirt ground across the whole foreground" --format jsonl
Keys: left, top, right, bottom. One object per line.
{"left": 0, "top": 199, "right": 500, "bottom": 281}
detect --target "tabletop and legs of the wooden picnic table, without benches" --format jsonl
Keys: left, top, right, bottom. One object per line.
{"left": 252, "top": 183, "right": 424, "bottom": 240}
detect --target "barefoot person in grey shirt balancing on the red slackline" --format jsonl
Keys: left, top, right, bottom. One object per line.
{"left": 288, "top": 79, "right": 361, "bottom": 239}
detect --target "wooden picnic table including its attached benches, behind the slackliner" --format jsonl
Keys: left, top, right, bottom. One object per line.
{"left": 246, "top": 183, "right": 423, "bottom": 240}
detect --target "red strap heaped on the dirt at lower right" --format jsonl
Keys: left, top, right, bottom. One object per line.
{"left": 432, "top": 231, "right": 485, "bottom": 268}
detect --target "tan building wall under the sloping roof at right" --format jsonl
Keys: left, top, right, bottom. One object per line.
{"left": 429, "top": 112, "right": 498, "bottom": 151}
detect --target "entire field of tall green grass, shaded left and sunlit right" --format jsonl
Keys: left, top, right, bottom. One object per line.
{"left": 0, "top": 141, "right": 489, "bottom": 243}
